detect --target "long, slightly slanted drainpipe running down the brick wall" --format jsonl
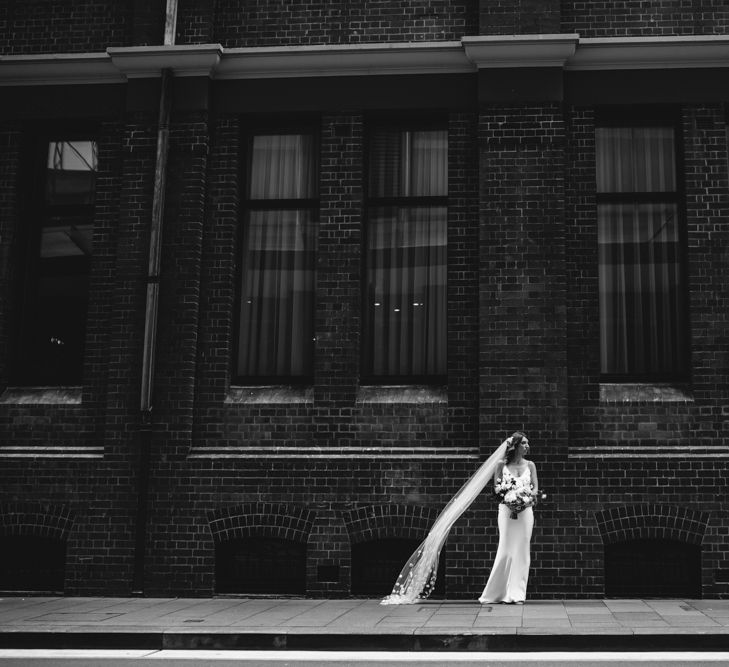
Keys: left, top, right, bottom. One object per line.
{"left": 132, "top": 0, "right": 178, "bottom": 595}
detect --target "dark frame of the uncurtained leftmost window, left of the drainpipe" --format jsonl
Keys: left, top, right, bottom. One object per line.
{"left": 8, "top": 126, "right": 100, "bottom": 387}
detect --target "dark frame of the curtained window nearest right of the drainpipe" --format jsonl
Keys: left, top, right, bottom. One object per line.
{"left": 229, "top": 120, "right": 321, "bottom": 387}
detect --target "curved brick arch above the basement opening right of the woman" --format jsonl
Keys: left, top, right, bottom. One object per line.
{"left": 595, "top": 504, "right": 709, "bottom": 545}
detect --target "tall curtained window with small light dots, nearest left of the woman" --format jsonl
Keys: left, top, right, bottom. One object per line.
{"left": 363, "top": 126, "right": 448, "bottom": 382}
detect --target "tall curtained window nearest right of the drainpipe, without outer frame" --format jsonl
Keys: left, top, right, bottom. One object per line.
{"left": 237, "top": 132, "right": 319, "bottom": 381}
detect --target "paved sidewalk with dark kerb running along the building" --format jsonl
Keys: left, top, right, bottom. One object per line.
{"left": 0, "top": 597, "right": 729, "bottom": 651}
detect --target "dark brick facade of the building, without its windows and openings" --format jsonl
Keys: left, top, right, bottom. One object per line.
{"left": 0, "top": 0, "right": 729, "bottom": 598}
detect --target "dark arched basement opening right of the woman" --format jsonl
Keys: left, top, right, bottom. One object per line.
{"left": 605, "top": 539, "right": 701, "bottom": 598}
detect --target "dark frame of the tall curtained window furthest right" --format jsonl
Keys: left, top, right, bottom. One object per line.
{"left": 594, "top": 107, "right": 691, "bottom": 384}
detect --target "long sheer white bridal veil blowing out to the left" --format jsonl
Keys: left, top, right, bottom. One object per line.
{"left": 380, "top": 440, "right": 508, "bottom": 604}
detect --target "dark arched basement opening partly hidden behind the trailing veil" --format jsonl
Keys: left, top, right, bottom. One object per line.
{"left": 352, "top": 537, "right": 445, "bottom": 597}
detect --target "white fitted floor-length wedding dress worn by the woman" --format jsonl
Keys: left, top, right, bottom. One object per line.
{"left": 478, "top": 466, "right": 534, "bottom": 604}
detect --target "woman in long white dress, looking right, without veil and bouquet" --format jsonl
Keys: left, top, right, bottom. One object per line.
{"left": 478, "top": 431, "right": 539, "bottom": 604}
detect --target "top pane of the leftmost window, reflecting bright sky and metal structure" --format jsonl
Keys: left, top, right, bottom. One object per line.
{"left": 46, "top": 141, "right": 97, "bottom": 205}
